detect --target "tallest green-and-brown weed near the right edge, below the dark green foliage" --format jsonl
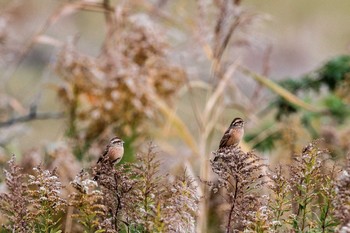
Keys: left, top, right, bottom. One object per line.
{"left": 290, "top": 141, "right": 334, "bottom": 231}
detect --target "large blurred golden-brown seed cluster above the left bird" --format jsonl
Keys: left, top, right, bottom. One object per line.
{"left": 56, "top": 10, "right": 185, "bottom": 142}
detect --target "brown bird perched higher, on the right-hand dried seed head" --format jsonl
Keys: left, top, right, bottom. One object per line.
{"left": 219, "top": 117, "right": 244, "bottom": 149}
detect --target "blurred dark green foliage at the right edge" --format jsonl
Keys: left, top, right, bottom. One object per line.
{"left": 252, "top": 55, "right": 350, "bottom": 151}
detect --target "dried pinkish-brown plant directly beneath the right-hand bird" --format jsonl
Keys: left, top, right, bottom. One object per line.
{"left": 210, "top": 146, "right": 265, "bottom": 233}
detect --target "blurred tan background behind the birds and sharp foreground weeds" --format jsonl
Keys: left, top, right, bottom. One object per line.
{"left": 0, "top": 0, "right": 350, "bottom": 231}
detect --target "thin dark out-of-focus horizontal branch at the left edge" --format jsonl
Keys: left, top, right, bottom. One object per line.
{"left": 0, "top": 108, "right": 64, "bottom": 128}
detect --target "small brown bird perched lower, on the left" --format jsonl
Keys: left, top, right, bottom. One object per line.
{"left": 97, "top": 137, "right": 124, "bottom": 164}
